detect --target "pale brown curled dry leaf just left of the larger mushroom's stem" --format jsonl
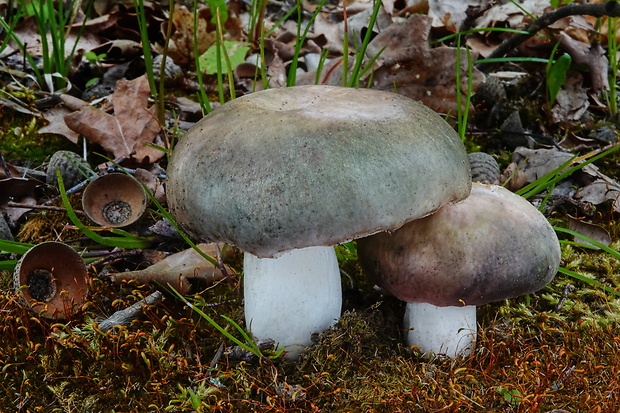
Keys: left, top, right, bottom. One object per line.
{"left": 109, "top": 243, "right": 233, "bottom": 294}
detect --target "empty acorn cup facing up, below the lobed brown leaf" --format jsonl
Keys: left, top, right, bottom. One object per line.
{"left": 82, "top": 173, "right": 147, "bottom": 228}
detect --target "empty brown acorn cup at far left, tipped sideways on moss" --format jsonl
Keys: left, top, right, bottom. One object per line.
{"left": 13, "top": 241, "right": 88, "bottom": 319}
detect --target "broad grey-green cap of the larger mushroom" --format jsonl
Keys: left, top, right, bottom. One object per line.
{"left": 167, "top": 86, "right": 471, "bottom": 257}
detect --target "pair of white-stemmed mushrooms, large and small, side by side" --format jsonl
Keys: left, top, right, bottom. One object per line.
{"left": 167, "top": 86, "right": 559, "bottom": 358}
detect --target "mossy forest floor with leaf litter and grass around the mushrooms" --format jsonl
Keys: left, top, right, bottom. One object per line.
{"left": 0, "top": 0, "right": 620, "bottom": 413}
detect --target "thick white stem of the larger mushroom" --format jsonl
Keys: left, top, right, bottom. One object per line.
{"left": 243, "top": 247, "right": 342, "bottom": 359}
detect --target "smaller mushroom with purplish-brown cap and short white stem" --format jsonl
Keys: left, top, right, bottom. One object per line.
{"left": 358, "top": 183, "right": 560, "bottom": 357}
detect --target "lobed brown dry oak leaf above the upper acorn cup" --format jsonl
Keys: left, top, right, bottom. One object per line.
{"left": 65, "top": 76, "right": 164, "bottom": 164}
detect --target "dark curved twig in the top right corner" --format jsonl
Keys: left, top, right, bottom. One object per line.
{"left": 476, "top": 1, "right": 620, "bottom": 70}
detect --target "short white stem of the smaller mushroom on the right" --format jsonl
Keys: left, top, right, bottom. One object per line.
{"left": 404, "top": 302, "right": 477, "bottom": 358}
